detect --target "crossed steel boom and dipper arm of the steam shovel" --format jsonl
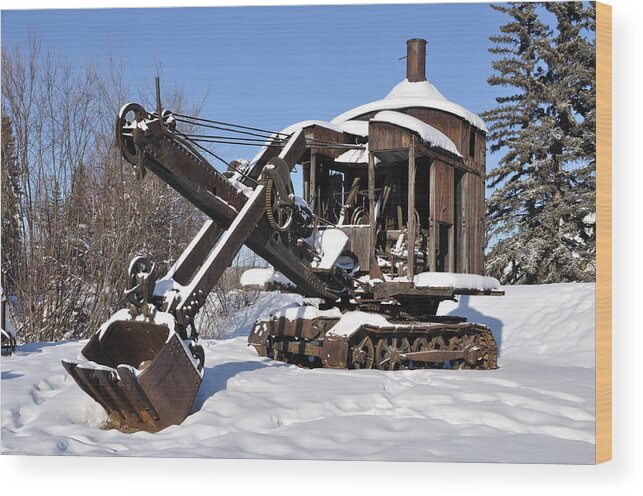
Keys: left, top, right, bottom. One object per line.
{"left": 116, "top": 105, "right": 341, "bottom": 338}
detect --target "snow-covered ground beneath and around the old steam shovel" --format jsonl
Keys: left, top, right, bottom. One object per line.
{"left": 1, "top": 284, "right": 595, "bottom": 463}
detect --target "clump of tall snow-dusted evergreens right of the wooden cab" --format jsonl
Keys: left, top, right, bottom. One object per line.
{"left": 484, "top": 2, "right": 595, "bottom": 284}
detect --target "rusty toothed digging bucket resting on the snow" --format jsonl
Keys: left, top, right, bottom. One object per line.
{"left": 63, "top": 310, "right": 203, "bottom": 432}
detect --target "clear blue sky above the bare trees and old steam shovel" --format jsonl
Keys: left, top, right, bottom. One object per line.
{"left": 2, "top": 4, "right": 506, "bottom": 194}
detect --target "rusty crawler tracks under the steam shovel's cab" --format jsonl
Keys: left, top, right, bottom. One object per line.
{"left": 248, "top": 318, "right": 498, "bottom": 370}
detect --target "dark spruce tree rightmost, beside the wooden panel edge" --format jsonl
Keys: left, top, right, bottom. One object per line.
{"left": 543, "top": 2, "right": 596, "bottom": 281}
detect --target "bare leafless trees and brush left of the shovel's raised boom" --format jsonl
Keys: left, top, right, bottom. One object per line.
{"left": 2, "top": 39, "right": 203, "bottom": 341}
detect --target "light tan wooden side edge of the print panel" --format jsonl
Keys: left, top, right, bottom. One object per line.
{"left": 596, "top": 2, "right": 612, "bottom": 463}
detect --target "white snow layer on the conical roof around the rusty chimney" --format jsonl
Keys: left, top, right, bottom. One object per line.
{"left": 330, "top": 79, "right": 488, "bottom": 133}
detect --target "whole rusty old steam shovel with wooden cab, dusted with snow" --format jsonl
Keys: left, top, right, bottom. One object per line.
{"left": 63, "top": 40, "right": 502, "bottom": 431}
